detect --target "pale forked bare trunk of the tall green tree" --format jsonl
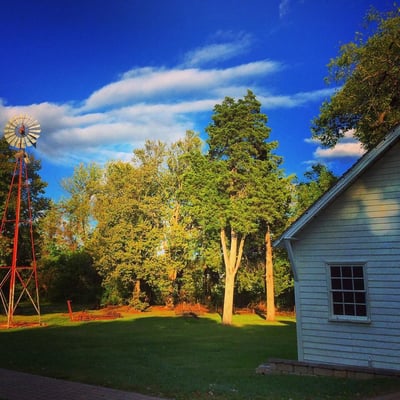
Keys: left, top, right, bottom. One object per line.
{"left": 220, "top": 229, "right": 245, "bottom": 325}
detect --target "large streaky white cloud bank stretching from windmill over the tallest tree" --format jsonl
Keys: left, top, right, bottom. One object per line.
{"left": 0, "top": 34, "right": 329, "bottom": 165}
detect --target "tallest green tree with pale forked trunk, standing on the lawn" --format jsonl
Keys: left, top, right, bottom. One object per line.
{"left": 187, "top": 91, "right": 288, "bottom": 324}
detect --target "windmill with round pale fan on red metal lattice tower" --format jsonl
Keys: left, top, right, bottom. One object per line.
{"left": 0, "top": 115, "right": 40, "bottom": 328}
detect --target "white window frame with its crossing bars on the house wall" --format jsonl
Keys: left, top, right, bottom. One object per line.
{"left": 326, "top": 261, "right": 371, "bottom": 323}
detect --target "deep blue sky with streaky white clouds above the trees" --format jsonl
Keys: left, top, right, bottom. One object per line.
{"left": 0, "top": 0, "right": 393, "bottom": 200}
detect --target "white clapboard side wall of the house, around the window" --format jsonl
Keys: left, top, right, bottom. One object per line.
{"left": 292, "top": 143, "right": 400, "bottom": 370}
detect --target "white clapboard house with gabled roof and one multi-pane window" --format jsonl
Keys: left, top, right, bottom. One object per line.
{"left": 275, "top": 127, "right": 400, "bottom": 371}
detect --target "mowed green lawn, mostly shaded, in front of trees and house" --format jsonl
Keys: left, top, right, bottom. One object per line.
{"left": 0, "top": 312, "right": 400, "bottom": 400}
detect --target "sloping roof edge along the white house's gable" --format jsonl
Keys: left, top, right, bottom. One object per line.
{"left": 274, "top": 126, "right": 400, "bottom": 247}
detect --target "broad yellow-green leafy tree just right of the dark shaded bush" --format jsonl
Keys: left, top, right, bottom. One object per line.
{"left": 90, "top": 150, "right": 167, "bottom": 306}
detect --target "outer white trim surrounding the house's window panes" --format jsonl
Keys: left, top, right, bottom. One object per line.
{"left": 325, "top": 260, "right": 371, "bottom": 324}
